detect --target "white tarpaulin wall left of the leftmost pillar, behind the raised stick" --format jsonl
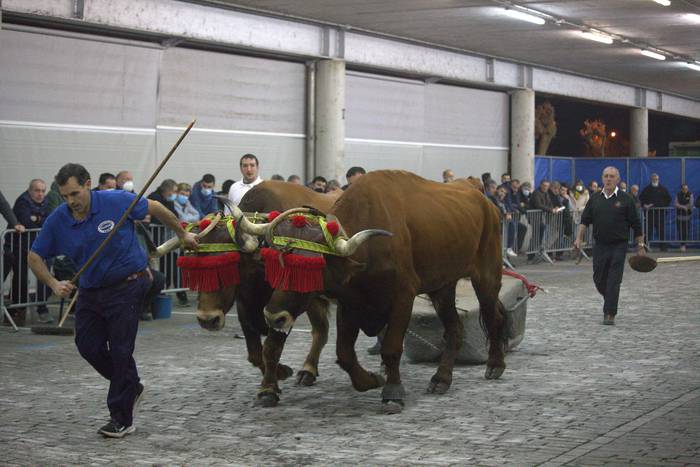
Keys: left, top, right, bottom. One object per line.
{"left": 0, "top": 30, "right": 305, "bottom": 203}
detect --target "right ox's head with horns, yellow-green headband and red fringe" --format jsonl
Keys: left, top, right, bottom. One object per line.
{"left": 234, "top": 208, "right": 392, "bottom": 332}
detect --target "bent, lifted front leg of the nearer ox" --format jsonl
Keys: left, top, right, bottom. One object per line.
{"left": 336, "top": 305, "right": 384, "bottom": 392}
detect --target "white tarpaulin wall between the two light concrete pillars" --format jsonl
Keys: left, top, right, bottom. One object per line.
{"left": 345, "top": 72, "right": 510, "bottom": 180}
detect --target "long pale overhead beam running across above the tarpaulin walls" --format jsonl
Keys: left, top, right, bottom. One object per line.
{"left": 1, "top": 0, "right": 700, "bottom": 118}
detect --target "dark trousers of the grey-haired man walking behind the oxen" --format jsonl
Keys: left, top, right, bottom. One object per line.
{"left": 593, "top": 242, "right": 627, "bottom": 316}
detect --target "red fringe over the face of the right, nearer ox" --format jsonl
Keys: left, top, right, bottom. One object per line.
{"left": 260, "top": 248, "right": 326, "bottom": 293}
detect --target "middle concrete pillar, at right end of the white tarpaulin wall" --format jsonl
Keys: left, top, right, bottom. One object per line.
{"left": 510, "top": 89, "right": 535, "bottom": 188}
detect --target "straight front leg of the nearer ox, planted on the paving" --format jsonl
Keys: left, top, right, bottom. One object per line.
{"left": 382, "top": 295, "right": 415, "bottom": 414}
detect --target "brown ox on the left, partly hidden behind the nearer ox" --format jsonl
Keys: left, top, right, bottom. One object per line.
{"left": 159, "top": 181, "right": 338, "bottom": 386}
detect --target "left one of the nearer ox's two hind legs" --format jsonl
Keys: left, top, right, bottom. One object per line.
{"left": 428, "top": 282, "right": 464, "bottom": 394}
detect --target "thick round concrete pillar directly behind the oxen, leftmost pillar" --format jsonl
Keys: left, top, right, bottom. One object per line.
{"left": 315, "top": 60, "right": 345, "bottom": 181}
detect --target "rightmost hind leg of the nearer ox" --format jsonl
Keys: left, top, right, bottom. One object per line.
{"left": 472, "top": 278, "right": 507, "bottom": 379}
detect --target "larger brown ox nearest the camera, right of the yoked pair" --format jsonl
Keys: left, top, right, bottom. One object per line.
{"left": 238, "top": 171, "right": 506, "bottom": 413}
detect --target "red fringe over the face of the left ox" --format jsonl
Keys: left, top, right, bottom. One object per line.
{"left": 177, "top": 251, "right": 241, "bottom": 292}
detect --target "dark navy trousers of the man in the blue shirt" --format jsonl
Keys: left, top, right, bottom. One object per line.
{"left": 75, "top": 276, "right": 151, "bottom": 426}
